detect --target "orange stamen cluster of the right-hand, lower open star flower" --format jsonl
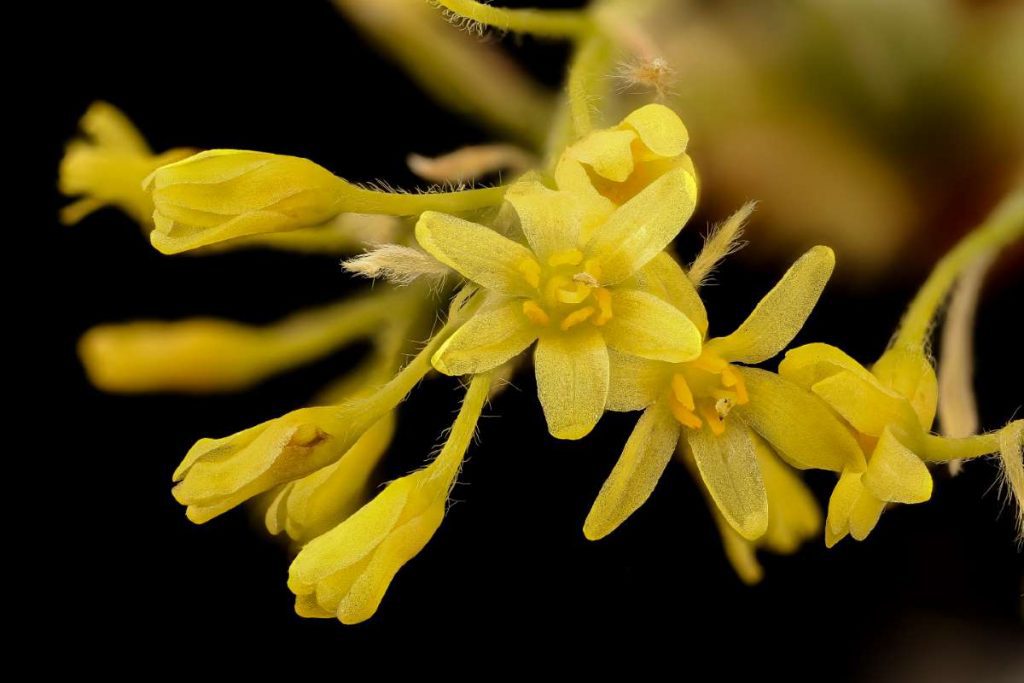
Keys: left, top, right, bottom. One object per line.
{"left": 669, "top": 348, "right": 750, "bottom": 435}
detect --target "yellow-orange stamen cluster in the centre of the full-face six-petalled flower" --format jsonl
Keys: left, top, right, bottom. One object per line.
{"left": 519, "top": 249, "right": 611, "bottom": 332}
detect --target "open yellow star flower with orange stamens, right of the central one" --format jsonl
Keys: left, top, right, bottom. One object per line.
{"left": 584, "top": 247, "right": 863, "bottom": 540}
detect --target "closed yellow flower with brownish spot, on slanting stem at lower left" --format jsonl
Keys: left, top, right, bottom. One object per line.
{"left": 172, "top": 302, "right": 474, "bottom": 523}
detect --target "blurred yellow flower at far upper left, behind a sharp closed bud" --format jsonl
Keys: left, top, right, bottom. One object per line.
{"left": 59, "top": 101, "right": 194, "bottom": 228}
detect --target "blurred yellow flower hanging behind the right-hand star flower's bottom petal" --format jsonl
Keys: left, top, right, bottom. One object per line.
{"left": 679, "top": 436, "right": 821, "bottom": 585}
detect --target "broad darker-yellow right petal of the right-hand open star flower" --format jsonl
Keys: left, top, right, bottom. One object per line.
{"left": 730, "top": 368, "right": 866, "bottom": 472}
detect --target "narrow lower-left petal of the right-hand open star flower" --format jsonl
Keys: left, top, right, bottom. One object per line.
{"left": 583, "top": 403, "right": 679, "bottom": 541}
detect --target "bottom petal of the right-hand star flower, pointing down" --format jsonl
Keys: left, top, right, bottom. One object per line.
{"left": 686, "top": 420, "right": 768, "bottom": 541}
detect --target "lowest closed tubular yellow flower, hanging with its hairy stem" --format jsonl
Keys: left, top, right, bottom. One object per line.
{"left": 288, "top": 374, "right": 492, "bottom": 624}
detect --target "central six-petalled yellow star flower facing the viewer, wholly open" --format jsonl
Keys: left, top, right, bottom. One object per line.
{"left": 416, "top": 169, "right": 700, "bottom": 439}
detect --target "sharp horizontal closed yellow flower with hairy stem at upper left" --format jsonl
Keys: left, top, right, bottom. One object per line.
{"left": 144, "top": 150, "right": 512, "bottom": 254}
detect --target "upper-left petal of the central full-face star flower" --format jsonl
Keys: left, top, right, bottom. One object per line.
{"left": 416, "top": 211, "right": 537, "bottom": 296}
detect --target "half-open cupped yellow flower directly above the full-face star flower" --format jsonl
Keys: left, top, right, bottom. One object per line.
{"left": 555, "top": 104, "right": 696, "bottom": 215}
